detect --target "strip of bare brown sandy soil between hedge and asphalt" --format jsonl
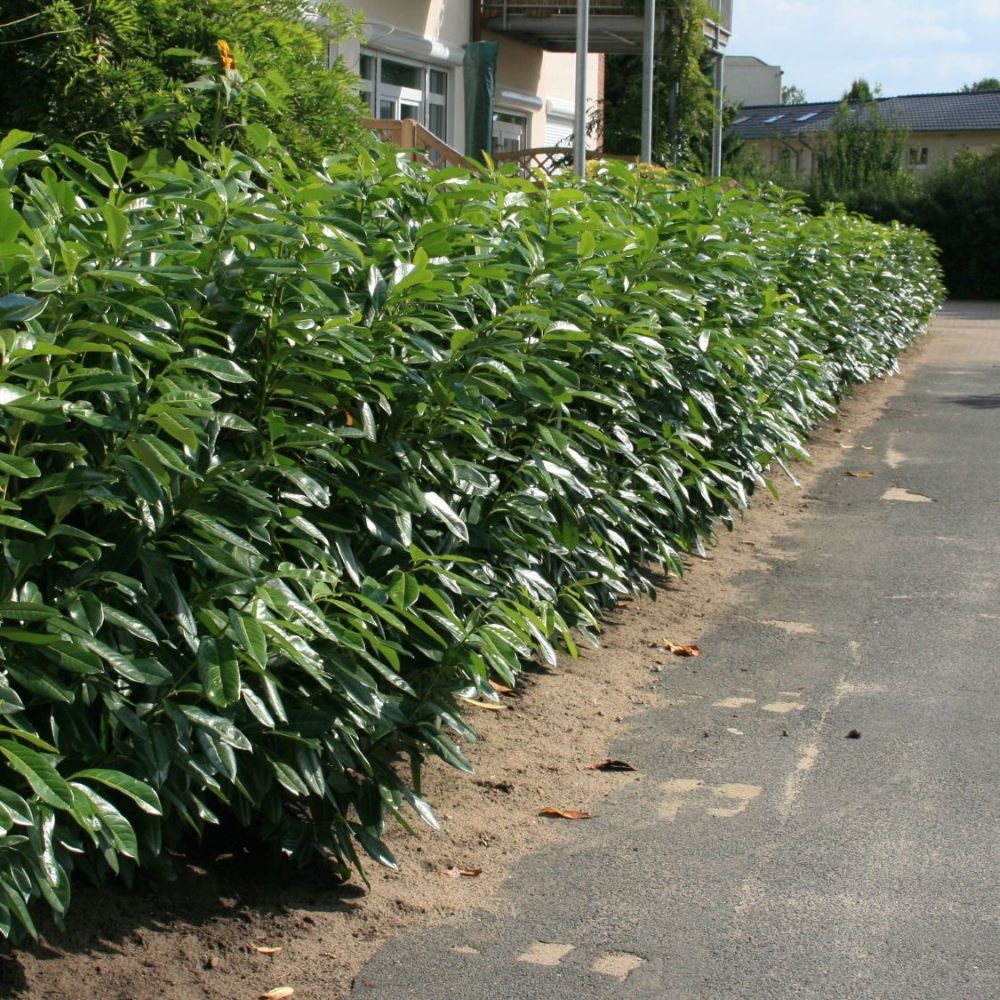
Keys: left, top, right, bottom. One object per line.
{"left": 0, "top": 344, "right": 923, "bottom": 1000}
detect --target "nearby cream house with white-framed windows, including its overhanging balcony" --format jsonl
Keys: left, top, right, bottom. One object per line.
{"left": 338, "top": 0, "right": 732, "bottom": 166}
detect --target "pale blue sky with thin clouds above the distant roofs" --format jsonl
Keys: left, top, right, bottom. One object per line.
{"left": 727, "top": 0, "right": 1000, "bottom": 101}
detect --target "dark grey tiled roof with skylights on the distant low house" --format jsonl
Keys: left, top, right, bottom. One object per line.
{"left": 731, "top": 90, "right": 1000, "bottom": 139}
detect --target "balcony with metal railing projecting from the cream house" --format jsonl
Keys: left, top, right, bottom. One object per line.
{"left": 482, "top": 0, "right": 733, "bottom": 54}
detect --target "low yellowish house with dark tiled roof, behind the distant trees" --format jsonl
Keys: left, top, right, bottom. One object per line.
{"left": 730, "top": 90, "right": 1000, "bottom": 177}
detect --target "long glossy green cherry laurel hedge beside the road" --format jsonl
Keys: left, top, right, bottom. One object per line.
{"left": 0, "top": 127, "right": 941, "bottom": 934}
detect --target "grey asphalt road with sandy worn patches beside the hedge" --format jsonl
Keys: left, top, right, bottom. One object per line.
{"left": 351, "top": 303, "right": 1000, "bottom": 1000}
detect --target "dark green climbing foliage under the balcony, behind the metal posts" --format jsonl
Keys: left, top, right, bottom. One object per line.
{"left": 590, "top": 0, "right": 716, "bottom": 168}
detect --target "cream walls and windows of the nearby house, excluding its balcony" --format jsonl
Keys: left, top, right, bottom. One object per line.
{"left": 339, "top": 0, "right": 603, "bottom": 152}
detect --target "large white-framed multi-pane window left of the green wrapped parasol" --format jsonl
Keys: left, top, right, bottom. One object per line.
{"left": 358, "top": 52, "right": 451, "bottom": 142}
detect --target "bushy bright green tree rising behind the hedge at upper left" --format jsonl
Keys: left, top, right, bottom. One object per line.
{"left": 0, "top": 0, "right": 361, "bottom": 158}
